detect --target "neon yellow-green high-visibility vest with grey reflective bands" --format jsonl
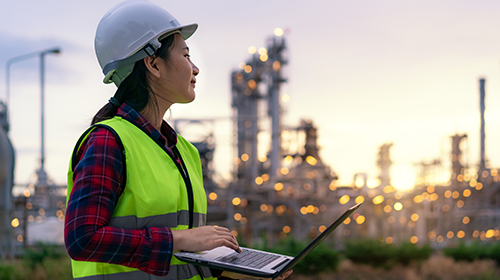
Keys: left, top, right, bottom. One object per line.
{"left": 67, "top": 117, "right": 213, "bottom": 280}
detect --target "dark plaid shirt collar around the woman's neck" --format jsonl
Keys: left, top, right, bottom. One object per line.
{"left": 116, "top": 103, "right": 177, "bottom": 147}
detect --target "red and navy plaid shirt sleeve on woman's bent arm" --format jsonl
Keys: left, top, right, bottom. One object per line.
{"left": 64, "top": 128, "right": 173, "bottom": 276}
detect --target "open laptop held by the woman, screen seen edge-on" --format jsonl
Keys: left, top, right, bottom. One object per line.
{"left": 174, "top": 203, "right": 361, "bottom": 279}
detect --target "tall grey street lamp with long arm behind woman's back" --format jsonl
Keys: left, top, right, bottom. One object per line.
{"left": 5, "top": 48, "right": 61, "bottom": 185}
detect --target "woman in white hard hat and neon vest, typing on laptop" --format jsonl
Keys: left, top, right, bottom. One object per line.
{"left": 65, "top": 1, "right": 288, "bottom": 280}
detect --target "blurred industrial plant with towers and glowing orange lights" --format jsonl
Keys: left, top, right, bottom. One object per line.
{"left": 0, "top": 30, "right": 500, "bottom": 254}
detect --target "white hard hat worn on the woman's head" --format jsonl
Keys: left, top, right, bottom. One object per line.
{"left": 94, "top": 0, "right": 198, "bottom": 86}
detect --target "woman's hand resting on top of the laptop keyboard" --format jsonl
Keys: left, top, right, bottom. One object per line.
{"left": 172, "top": 226, "right": 241, "bottom": 253}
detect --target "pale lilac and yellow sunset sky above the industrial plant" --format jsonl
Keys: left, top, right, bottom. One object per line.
{"left": 0, "top": 0, "right": 500, "bottom": 191}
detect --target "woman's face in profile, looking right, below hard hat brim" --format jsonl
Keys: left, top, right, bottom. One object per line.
{"left": 155, "top": 34, "right": 200, "bottom": 104}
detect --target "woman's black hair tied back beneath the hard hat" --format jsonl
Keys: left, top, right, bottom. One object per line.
{"left": 91, "top": 34, "right": 174, "bottom": 125}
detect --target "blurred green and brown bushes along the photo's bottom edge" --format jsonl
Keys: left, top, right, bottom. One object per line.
{"left": 0, "top": 238, "right": 500, "bottom": 280}
